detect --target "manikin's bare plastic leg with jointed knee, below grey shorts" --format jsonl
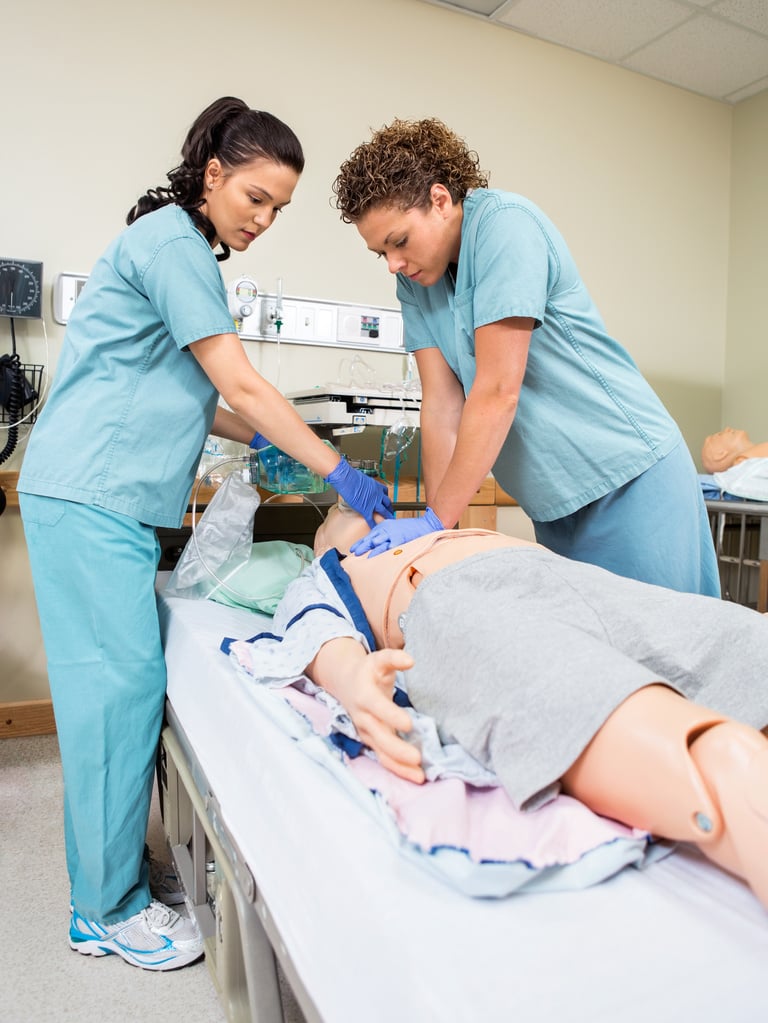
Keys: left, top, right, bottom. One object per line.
{"left": 562, "top": 684, "right": 768, "bottom": 907}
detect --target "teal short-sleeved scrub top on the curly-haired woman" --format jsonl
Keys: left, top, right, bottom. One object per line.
{"left": 397, "top": 188, "right": 681, "bottom": 522}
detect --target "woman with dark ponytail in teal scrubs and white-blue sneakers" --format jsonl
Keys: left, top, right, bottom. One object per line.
{"left": 18, "top": 96, "right": 392, "bottom": 970}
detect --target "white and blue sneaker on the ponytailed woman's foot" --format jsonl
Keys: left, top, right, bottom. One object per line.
{"left": 70, "top": 902, "right": 204, "bottom": 970}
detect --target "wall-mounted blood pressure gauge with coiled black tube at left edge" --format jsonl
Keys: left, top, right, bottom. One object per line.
{"left": 0, "top": 259, "right": 48, "bottom": 464}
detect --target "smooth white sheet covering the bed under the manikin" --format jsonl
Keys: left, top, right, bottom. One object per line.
{"left": 161, "top": 598, "right": 768, "bottom": 1023}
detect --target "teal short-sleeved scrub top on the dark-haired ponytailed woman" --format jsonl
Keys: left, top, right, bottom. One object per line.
{"left": 18, "top": 205, "right": 235, "bottom": 527}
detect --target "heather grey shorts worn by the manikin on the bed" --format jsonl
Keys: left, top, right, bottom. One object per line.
{"left": 404, "top": 547, "right": 768, "bottom": 808}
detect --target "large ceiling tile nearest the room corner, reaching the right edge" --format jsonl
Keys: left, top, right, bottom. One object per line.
{"left": 621, "top": 15, "right": 768, "bottom": 98}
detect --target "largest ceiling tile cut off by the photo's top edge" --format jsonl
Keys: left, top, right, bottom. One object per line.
{"left": 494, "top": 0, "right": 695, "bottom": 60}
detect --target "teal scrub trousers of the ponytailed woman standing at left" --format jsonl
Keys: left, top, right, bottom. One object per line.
{"left": 19, "top": 494, "right": 166, "bottom": 924}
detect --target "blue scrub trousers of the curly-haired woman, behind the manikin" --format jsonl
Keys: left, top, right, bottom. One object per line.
{"left": 534, "top": 443, "right": 720, "bottom": 597}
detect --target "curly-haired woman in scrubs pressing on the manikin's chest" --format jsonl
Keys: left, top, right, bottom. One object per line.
{"left": 333, "top": 119, "right": 720, "bottom": 595}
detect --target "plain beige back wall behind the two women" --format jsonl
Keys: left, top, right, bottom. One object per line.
{"left": 0, "top": 0, "right": 765, "bottom": 701}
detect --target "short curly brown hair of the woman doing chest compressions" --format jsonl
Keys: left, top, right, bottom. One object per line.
{"left": 331, "top": 118, "right": 488, "bottom": 224}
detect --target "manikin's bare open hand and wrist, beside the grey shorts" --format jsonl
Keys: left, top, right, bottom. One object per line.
{"left": 306, "top": 636, "right": 424, "bottom": 784}
